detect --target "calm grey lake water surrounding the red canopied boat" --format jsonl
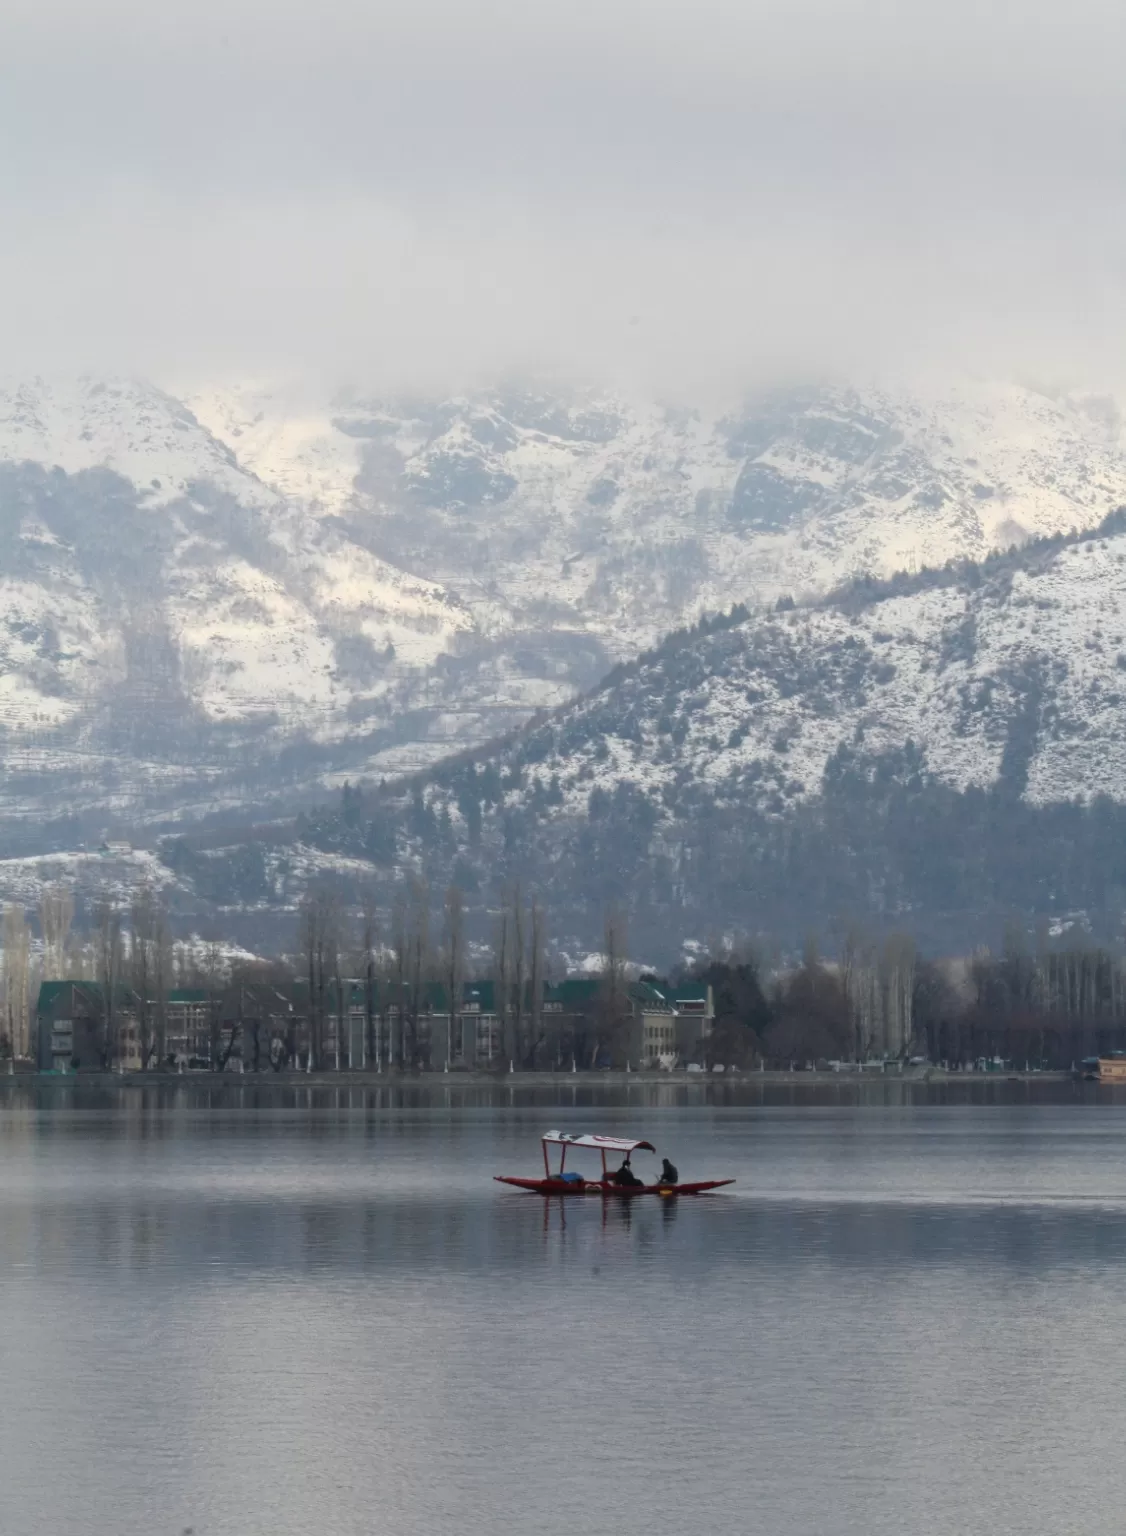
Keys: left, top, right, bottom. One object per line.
{"left": 0, "top": 1087, "right": 1126, "bottom": 1536}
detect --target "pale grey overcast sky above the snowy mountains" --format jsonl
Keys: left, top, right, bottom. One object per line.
{"left": 0, "top": 0, "right": 1126, "bottom": 396}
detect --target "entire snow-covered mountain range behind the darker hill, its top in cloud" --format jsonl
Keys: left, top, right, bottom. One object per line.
{"left": 0, "top": 368, "right": 1126, "bottom": 852}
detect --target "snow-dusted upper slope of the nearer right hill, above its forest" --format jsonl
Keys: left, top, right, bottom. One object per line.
{"left": 388, "top": 518, "right": 1126, "bottom": 866}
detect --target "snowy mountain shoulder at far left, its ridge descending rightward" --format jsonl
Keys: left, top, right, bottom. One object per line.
{"left": 0, "top": 379, "right": 473, "bottom": 817}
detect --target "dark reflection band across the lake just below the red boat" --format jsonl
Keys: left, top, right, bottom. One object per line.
{"left": 17, "top": 1173, "right": 1126, "bottom": 1276}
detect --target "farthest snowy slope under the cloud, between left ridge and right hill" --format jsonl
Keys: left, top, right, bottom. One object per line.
{"left": 197, "top": 382, "right": 1126, "bottom": 657}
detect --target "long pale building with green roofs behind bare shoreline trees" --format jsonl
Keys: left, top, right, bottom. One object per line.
{"left": 35, "top": 977, "right": 714, "bottom": 1072}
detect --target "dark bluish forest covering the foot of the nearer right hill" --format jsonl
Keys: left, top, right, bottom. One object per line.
{"left": 274, "top": 715, "right": 1126, "bottom": 954}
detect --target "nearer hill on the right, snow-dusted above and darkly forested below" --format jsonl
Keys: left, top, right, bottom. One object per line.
{"left": 285, "top": 513, "right": 1126, "bottom": 951}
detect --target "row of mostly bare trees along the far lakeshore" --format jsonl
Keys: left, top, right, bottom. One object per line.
{"left": 10, "top": 877, "right": 1126, "bottom": 1071}
